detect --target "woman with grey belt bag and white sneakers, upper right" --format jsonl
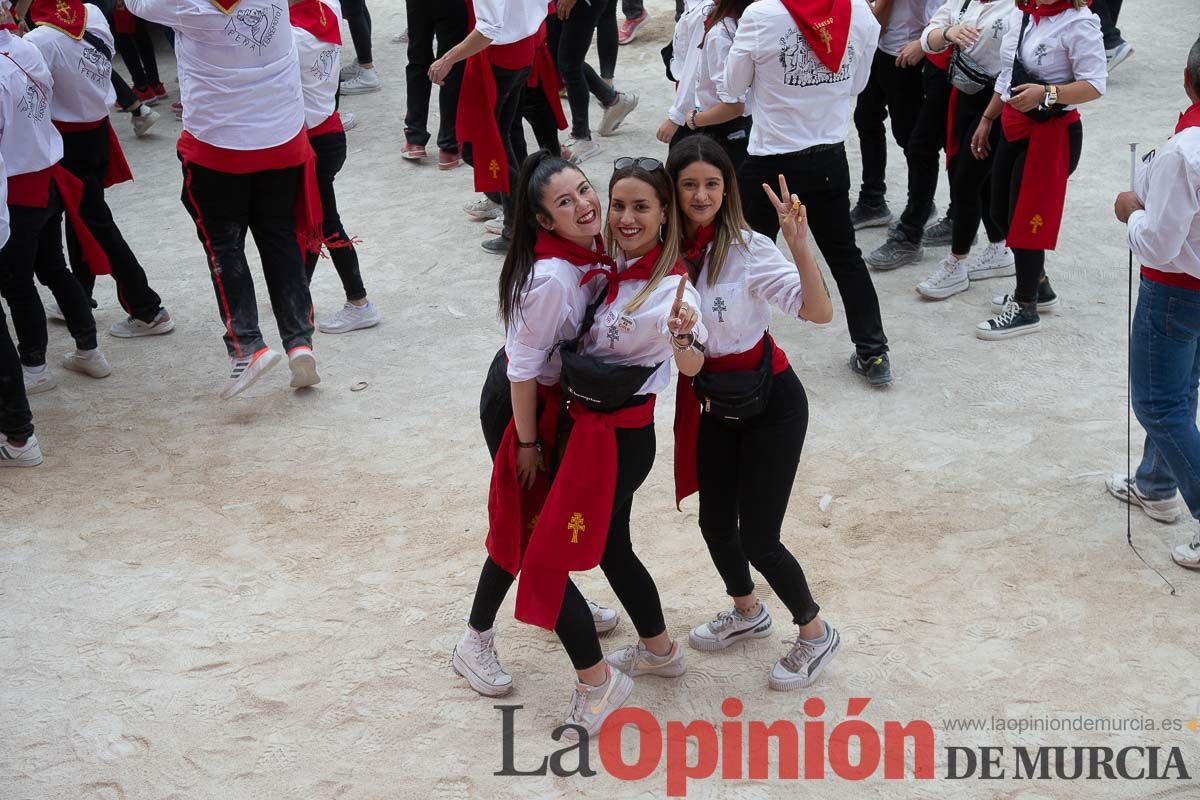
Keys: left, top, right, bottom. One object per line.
{"left": 917, "top": 0, "right": 1014, "bottom": 300}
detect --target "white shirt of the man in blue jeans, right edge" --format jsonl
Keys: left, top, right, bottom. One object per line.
{"left": 1128, "top": 127, "right": 1200, "bottom": 278}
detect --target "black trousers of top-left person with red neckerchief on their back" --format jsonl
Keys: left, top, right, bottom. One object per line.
{"left": 62, "top": 125, "right": 162, "bottom": 323}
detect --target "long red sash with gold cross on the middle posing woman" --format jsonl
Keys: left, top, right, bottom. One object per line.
{"left": 516, "top": 396, "right": 654, "bottom": 628}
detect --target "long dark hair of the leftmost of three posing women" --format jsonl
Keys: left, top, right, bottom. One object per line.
{"left": 499, "top": 150, "right": 586, "bottom": 327}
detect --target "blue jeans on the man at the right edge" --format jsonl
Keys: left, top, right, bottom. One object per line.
{"left": 1129, "top": 278, "right": 1200, "bottom": 519}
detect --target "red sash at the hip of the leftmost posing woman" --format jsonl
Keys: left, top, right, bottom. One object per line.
{"left": 487, "top": 384, "right": 563, "bottom": 576}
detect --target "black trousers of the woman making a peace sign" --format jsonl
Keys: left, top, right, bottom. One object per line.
{"left": 696, "top": 367, "right": 821, "bottom": 625}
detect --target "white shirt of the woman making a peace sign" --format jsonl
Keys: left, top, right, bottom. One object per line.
{"left": 696, "top": 230, "right": 804, "bottom": 357}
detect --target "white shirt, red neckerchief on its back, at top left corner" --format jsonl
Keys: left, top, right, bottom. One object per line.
{"left": 25, "top": 2, "right": 116, "bottom": 122}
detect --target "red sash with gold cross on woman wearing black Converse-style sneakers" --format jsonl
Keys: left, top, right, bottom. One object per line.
{"left": 1000, "top": 103, "right": 1079, "bottom": 249}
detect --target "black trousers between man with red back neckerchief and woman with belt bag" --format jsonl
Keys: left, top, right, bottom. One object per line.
{"left": 854, "top": 50, "right": 944, "bottom": 242}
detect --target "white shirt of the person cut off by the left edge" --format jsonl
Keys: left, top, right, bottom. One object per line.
{"left": 0, "top": 31, "right": 62, "bottom": 176}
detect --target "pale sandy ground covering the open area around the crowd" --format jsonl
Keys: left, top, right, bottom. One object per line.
{"left": 0, "top": 0, "right": 1200, "bottom": 800}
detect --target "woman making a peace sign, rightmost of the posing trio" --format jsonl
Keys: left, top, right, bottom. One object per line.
{"left": 667, "top": 137, "right": 841, "bottom": 691}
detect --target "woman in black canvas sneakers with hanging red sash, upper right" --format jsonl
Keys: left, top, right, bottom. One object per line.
{"left": 971, "top": 0, "right": 1108, "bottom": 341}
